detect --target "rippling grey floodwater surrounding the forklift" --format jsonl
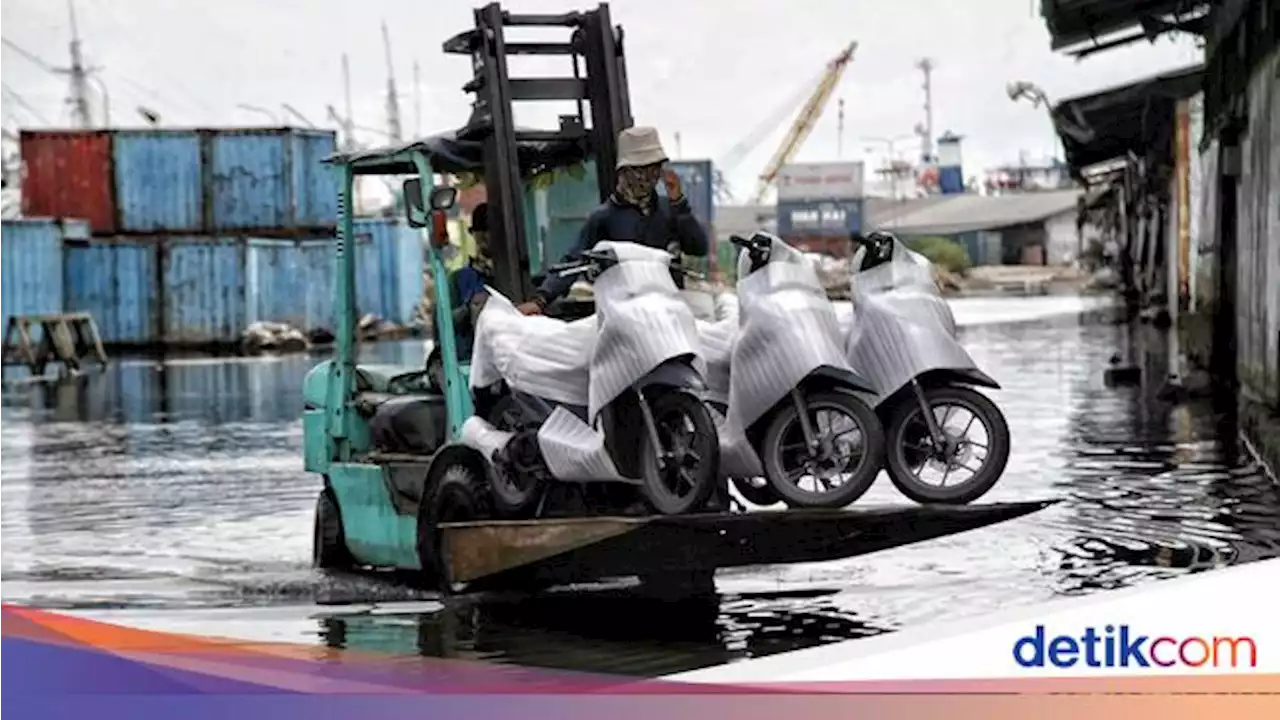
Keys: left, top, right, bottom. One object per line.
{"left": 0, "top": 297, "right": 1280, "bottom": 675}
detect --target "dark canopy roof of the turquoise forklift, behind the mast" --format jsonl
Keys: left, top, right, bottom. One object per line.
{"left": 324, "top": 128, "right": 586, "bottom": 177}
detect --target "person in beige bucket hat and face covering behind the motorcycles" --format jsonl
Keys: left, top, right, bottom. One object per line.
{"left": 520, "top": 127, "right": 709, "bottom": 315}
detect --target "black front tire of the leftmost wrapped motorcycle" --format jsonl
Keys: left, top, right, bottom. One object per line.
{"left": 640, "top": 391, "right": 719, "bottom": 515}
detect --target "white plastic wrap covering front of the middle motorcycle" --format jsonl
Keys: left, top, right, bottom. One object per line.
{"left": 721, "top": 238, "right": 850, "bottom": 475}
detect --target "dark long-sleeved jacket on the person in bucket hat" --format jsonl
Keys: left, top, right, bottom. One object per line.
{"left": 534, "top": 192, "right": 708, "bottom": 305}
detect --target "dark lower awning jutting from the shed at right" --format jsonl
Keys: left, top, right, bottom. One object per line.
{"left": 1053, "top": 64, "right": 1204, "bottom": 176}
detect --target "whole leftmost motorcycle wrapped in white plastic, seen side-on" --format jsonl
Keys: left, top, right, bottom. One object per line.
{"left": 462, "top": 242, "right": 719, "bottom": 516}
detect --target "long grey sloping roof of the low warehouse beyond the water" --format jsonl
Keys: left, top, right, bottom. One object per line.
{"left": 870, "top": 190, "right": 1084, "bottom": 234}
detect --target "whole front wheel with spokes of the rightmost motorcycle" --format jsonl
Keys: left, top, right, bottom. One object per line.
{"left": 886, "top": 387, "right": 1009, "bottom": 505}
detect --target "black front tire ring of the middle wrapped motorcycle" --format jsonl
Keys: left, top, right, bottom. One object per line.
{"left": 760, "top": 392, "right": 884, "bottom": 509}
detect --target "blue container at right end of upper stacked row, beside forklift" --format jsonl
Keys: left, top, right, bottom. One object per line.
{"left": 206, "top": 129, "right": 338, "bottom": 233}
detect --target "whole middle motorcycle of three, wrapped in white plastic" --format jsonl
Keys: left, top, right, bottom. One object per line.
{"left": 701, "top": 233, "right": 883, "bottom": 507}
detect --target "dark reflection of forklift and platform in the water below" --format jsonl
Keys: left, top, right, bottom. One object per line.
{"left": 320, "top": 591, "right": 890, "bottom": 676}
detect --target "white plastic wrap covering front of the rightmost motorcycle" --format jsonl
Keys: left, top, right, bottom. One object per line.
{"left": 845, "top": 241, "right": 977, "bottom": 402}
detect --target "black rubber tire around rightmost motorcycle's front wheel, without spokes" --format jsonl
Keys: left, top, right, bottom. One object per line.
{"left": 884, "top": 387, "right": 1009, "bottom": 505}
